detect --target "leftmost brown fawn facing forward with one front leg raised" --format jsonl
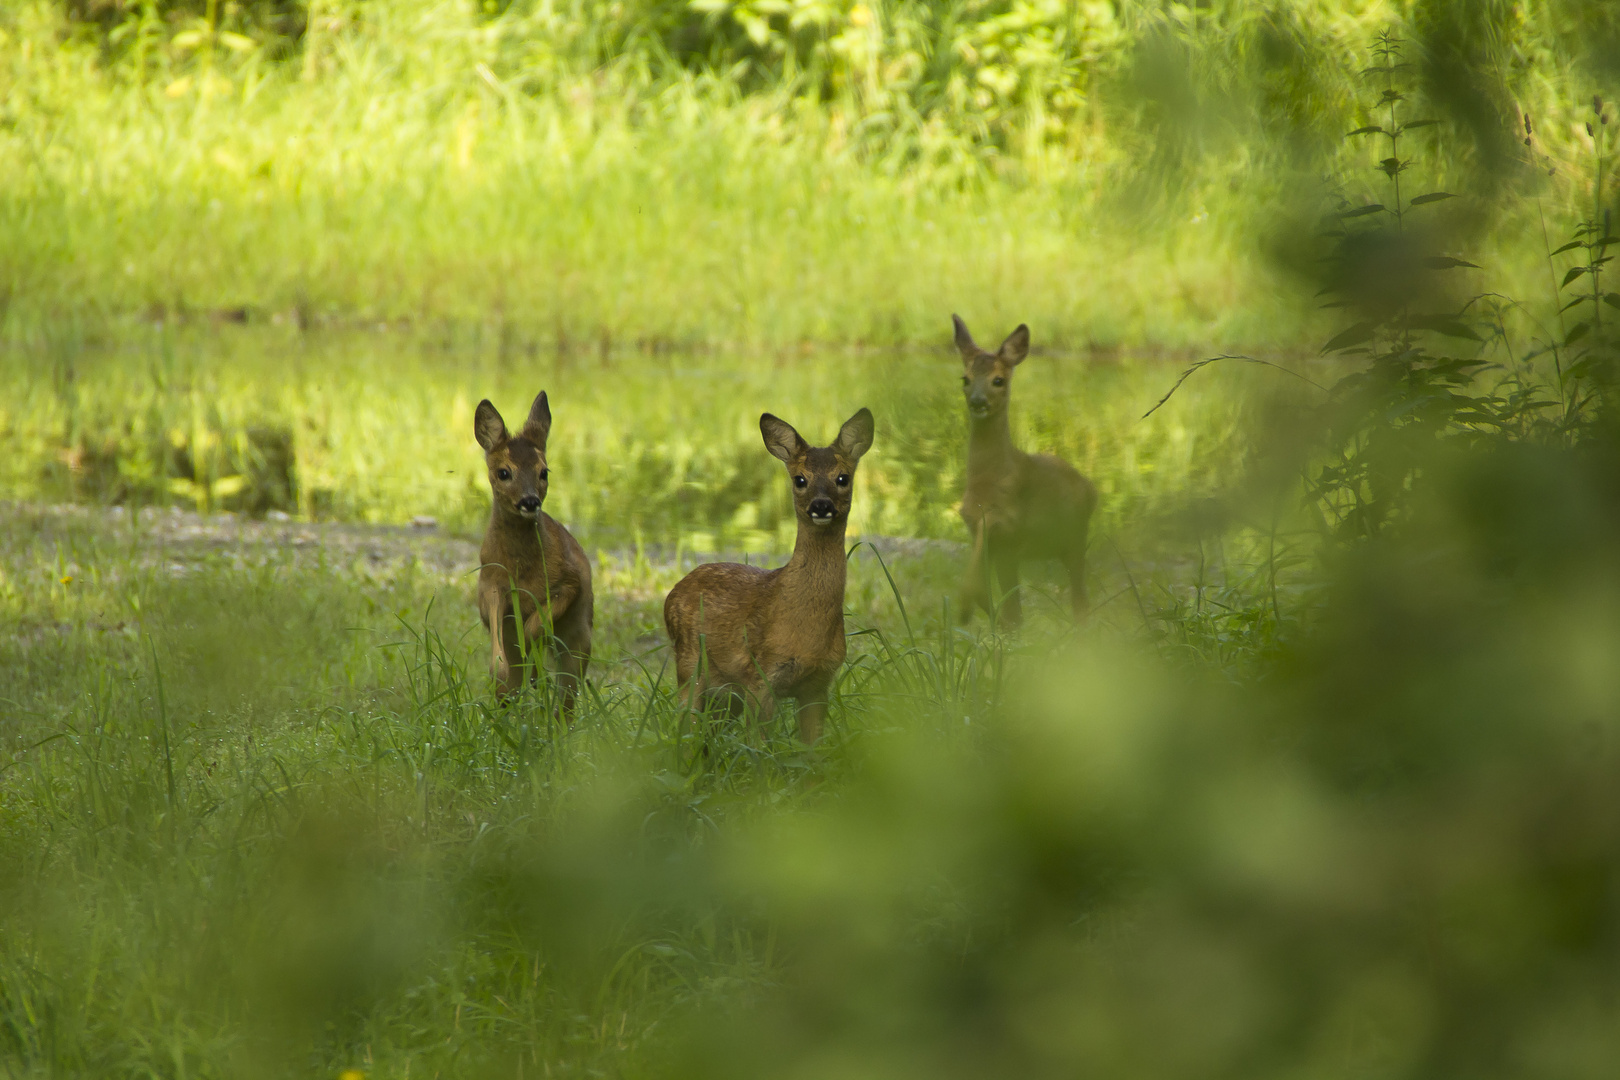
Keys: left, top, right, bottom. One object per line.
{"left": 473, "top": 390, "right": 593, "bottom": 719}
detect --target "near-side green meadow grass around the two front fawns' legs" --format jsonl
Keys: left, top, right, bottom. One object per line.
{"left": 0, "top": 510, "right": 1049, "bottom": 1075}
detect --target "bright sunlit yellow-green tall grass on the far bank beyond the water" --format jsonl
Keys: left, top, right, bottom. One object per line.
{"left": 0, "top": 3, "right": 1296, "bottom": 348}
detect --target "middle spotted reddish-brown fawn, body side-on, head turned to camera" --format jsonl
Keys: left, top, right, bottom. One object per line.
{"left": 664, "top": 408, "right": 873, "bottom": 743}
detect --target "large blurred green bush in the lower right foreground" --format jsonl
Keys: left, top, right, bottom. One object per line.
{"left": 651, "top": 433, "right": 1620, "bottom": 1078}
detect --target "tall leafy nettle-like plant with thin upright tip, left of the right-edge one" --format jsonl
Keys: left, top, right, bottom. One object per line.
{"left": 1307, "top": 32, "right": 1557, "bottom": 539}
